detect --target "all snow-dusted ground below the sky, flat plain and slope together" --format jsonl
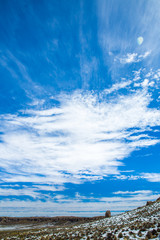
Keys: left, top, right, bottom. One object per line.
{"left": 0, "top": 198, "right": 160, "bottom": 240}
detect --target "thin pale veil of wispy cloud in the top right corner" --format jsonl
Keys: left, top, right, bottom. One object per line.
{"left": 97, "top": 0, "right": 160, "bottom": 59}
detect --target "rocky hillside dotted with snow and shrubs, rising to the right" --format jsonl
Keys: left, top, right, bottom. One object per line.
{"left": 1, "top": 199, "right": 160, "bottom": 240}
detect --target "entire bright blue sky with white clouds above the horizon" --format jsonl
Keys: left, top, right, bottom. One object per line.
{"left": 0, "top": 0, "right": 160, "bottom": 217}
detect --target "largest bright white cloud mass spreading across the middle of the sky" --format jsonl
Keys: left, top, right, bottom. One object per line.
{"left": 0, "top": 87, "right": 160, "bottom": 187}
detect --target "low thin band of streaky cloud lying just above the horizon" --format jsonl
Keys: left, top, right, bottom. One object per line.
{"left": 0, "top": 190, "right": 159, "bottom": 216}
